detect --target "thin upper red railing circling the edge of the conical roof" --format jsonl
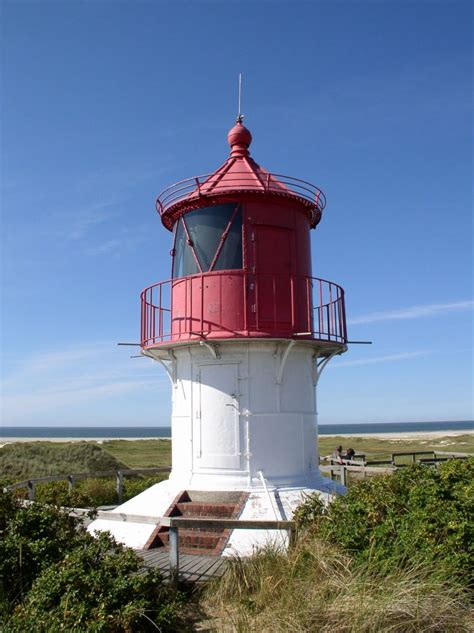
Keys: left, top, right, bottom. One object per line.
{"left": 156, "top": 172, "right": 326, "bottom": 215}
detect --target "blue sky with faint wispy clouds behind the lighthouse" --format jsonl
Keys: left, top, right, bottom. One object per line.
{"left": 1, "top": 0, "right": 474, "bottom": 426}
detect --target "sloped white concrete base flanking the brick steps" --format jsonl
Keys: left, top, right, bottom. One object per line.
{"left": 87, "top": 475, "right": 346, "bottom": 556}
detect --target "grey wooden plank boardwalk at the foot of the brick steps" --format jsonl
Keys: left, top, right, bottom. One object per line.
{"left": 137, "top": 548, "right": 227, "bottom": 583}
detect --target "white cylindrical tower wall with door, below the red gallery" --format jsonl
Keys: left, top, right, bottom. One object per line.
{"left": 163, "top": 340, "right": 318, "bottom": 490}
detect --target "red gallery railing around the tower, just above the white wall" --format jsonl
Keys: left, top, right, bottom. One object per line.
{"left": 140, "top": 270, "right": 347, "bottom": 347}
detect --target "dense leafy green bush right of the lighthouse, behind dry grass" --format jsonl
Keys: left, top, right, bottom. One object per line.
{"left": 295, "top": 459, "right": 474, "bottom": 580}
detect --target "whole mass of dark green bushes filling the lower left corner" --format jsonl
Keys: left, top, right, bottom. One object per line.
{"left": 0, "top": 491, "right": 183, "bottom": 633}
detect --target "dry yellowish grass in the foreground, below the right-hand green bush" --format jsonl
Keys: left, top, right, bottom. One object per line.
{"left": 203, "top": 537, "right": 474, "bottom": 633}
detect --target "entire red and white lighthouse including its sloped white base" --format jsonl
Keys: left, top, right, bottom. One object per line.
{"left": 92, "top": 116, "right": 347, "bottom": 556}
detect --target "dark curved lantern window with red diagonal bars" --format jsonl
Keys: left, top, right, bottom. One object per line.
{"left": 173, "top": 203, "right": 242, "bottom": 277}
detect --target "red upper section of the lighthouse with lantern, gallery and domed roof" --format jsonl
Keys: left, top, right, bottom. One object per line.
{"left": 141, "top": 120, "right": 347, "bottom": 350}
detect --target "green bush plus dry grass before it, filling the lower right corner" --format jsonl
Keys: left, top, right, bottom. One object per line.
{"left": 203, "top": 459, "right": 474, "bottom": 633}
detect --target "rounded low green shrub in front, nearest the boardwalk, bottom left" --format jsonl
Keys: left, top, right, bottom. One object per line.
{"left": 6, "top": 534, "right": 185, "bottom": 633}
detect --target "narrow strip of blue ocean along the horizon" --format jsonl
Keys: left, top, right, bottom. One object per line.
{"left": 0, "top": 420, "right": 474, "bottom": 440}
